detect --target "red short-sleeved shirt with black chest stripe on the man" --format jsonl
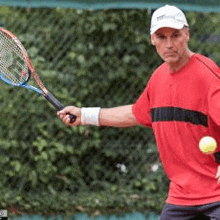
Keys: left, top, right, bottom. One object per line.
{"left": 133, "top": 54, "right": 220, "bottom": 205}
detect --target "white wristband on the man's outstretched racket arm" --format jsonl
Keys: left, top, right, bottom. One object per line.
{"left": 81, "top": 107, "right": 101, "bottom": 126}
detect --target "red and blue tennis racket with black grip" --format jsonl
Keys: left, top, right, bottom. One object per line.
{"left": 0, "top": 27, "right": 76, "bottom": 122}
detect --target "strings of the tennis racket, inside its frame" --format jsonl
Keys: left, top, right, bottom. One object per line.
{"left": 0, "top": 32, "right": 29, "bottom": 85}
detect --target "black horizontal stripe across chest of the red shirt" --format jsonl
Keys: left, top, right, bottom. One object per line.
{"left": 151, "top": 107, "right": 208, "bottom": 127}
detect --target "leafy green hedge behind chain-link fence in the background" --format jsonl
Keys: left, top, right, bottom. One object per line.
{"left": 0, "top": 3, "right": 220, "bottom": 218}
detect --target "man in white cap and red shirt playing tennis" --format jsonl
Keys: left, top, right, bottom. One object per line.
{"left": 58, "top": 5, "right": 220, "bottom": 220}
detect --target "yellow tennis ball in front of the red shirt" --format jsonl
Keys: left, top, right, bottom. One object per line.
{"left": 199, "top": 136, "right": 217, "bottom": 154}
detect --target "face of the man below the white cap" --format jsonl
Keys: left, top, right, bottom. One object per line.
{"left": 151, "top": 27, "right": 189, "bottom": 65}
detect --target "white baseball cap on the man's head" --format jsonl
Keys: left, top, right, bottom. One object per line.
{"left": 150, "top": 5, "right": 189, "bottom": 35}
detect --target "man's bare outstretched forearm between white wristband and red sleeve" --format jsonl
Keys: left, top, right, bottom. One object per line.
{"left": 99, "top": 105, "right": 139, "bottom": 127}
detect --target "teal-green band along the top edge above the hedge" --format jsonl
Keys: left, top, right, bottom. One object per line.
{"left": 0, "top": 0, "right": 220, "bottom": 12}
